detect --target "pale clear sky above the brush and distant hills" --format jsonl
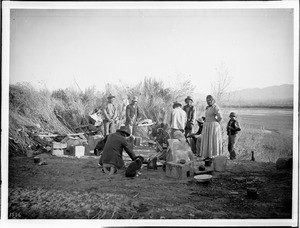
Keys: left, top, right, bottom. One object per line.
{"left": 10, "top": 3, "right": 294, "bottom": 93}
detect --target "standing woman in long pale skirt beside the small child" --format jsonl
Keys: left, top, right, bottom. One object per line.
{"left": 200, "top": 95, "right": 222, "bottom": 158}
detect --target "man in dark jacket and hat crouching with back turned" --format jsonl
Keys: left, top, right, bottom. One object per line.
{"left": 99, "top": 126, "right": 136, "bottom": 175}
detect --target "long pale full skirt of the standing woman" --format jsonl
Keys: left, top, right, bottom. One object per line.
{"left": 200, "top": 122, "right": 222, "bottom": 158}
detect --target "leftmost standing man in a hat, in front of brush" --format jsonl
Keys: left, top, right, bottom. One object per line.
{"left": 103, "top": 95, "right": 118, "bottom": 136}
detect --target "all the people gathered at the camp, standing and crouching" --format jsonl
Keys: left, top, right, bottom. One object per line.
{"left": 99, "top": 95, "right": 241, "bottom": 174}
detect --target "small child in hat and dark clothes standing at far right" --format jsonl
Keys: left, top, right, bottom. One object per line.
{"left": 227, "top": 112, "right": 241, "bottom": 160}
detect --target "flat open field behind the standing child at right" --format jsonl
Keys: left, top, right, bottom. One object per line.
{"left": 222, "top": 108, "right": 293, "bottom": 162}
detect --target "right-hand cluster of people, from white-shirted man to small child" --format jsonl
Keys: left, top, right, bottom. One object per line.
{"left": 170, "top": 95, "right": 241, "bottom": 159}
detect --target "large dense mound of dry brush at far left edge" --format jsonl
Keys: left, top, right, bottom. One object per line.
{"left": 9, "top": 83, "right": 70, "bottom": 151}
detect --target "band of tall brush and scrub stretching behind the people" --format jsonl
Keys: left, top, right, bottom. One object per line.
{"left": 9, "top": 78, "right": 292, "bottom": 162}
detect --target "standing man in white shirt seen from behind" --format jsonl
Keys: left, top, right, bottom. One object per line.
{"left": 170, "top": 101, "right": 186, "bottom": 139}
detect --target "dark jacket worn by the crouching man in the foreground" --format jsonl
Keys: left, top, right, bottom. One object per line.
{"left": 99, "top": 132, "right": 136, "bottom": 169}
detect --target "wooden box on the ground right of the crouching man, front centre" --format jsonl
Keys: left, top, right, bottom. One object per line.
{"left": 166, "top": 162, "right": 194, "bottom": 179}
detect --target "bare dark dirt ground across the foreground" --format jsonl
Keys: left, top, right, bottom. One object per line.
{"left": 9, "top": 152, "right": 292, "bottom": 219}
